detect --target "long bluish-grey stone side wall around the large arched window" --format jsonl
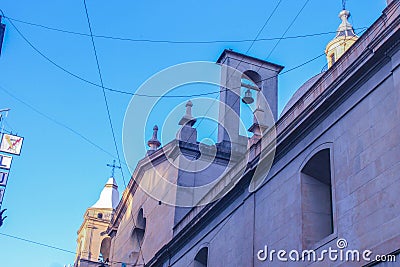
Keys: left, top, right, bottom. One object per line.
{"left": 166, "top": 37, "right": 400, "bottom": 266}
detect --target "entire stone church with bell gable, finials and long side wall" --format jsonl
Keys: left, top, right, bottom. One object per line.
{"left": 74, "top": 0, "right": 400, "bottom": 267}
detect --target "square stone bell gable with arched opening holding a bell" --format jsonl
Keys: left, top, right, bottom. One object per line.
{"left": 217, "top": 50, "right": 283, "bottom": 148}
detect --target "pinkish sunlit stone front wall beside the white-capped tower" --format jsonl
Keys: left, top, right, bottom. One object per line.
{"left": 111, "top": 161, "right": 177, "bottom": 267}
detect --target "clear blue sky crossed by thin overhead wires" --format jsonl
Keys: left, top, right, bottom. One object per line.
{"left": 0, "top": 0, "right": 386, "bottom": 267}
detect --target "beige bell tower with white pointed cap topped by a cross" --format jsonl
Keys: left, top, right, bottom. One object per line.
{"left": 74, "top": 177, "right": 119, "bottom": 267}
